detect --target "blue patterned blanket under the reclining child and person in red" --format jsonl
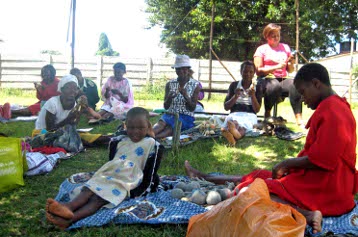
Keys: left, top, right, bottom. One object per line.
{"left": 55, "top": 173, "right": 358, "bottom": 236}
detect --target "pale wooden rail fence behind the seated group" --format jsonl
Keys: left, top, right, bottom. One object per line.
{"left": 0, "top": 55, "right": 358, "bottom": 101}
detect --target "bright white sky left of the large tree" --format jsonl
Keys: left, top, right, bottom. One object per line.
{"left": 0, "top": 0, "right": 166, "bottom": 57}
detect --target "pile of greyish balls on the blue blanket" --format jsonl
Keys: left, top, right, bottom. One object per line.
{"left": 170, "top": 181, "right": 235, "bottom": 205}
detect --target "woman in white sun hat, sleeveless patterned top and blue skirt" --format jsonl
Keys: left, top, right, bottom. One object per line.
{"left": 153, "top": 55, "right": 200, "bottom": 138}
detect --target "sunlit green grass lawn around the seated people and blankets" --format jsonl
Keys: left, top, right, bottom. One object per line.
{"left": 0, "top": 94, "right": 358, "bottom": 236}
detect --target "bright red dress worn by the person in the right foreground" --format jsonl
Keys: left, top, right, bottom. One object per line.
{"left": 238, "top": 95, "right": 358, "bottom": 216}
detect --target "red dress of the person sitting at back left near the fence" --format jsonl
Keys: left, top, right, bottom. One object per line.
{"left": 28, "top": 77, "right": 61, "bottom": 115}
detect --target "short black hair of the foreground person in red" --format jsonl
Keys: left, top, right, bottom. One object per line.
{"left": 294, "top": 63, "right": 331, "bottom": 86}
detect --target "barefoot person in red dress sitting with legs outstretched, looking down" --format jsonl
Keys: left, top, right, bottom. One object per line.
{"left": 185, "top": 63, "right": 358, "bottom": 233}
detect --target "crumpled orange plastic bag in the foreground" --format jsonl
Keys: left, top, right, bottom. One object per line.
{"left": 186, "top": 179, "right": 306, "bottom": 237}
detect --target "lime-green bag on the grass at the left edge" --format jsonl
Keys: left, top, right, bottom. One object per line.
{"left": 0, "top": 137, "right": 27, "bottom": 193}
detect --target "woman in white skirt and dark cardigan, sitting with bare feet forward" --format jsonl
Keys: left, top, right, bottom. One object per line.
{"left": 221, "top": 61, "right": 263, "bottom": 145}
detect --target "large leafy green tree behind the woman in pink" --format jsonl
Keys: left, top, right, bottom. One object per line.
{"left": 146, "top": 0, "right": 358, "bottom": 60}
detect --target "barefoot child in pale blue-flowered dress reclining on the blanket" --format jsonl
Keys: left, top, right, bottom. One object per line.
{"left": 46, "top": 107, "right": 161, "bottom": 229}
